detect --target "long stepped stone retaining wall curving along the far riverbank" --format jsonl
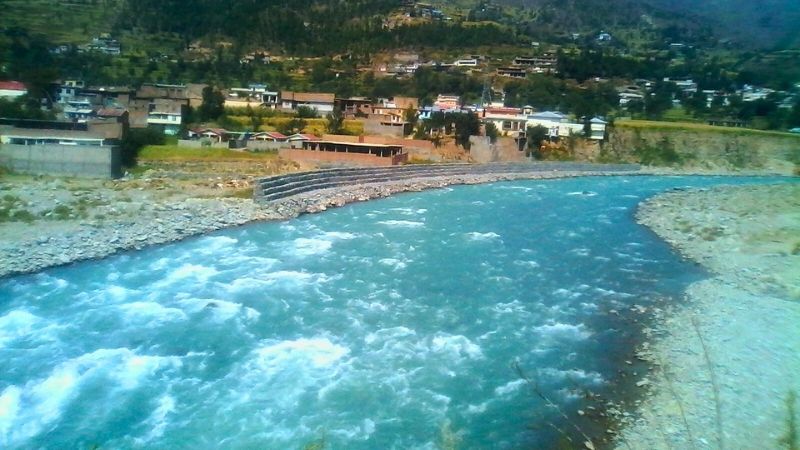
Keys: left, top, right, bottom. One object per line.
{"left": 254, "top": 162, "right": 640, "bottom": 202}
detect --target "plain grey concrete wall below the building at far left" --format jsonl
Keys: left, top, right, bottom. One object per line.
{"left": 0, "top": 144, "right": 122, "bottom": 178}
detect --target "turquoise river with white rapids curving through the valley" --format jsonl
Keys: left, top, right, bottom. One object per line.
{"left": 0, "top": 176, "right": 788, "bottom": 449}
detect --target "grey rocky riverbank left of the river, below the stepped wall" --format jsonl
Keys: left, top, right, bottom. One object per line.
{"left": 0, "top": 172, "right": 636, "bottom": 276}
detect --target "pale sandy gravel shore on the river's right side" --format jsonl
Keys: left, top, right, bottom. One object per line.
{"left": 617, "top": 184, "right": 800, "bottom": 449}
